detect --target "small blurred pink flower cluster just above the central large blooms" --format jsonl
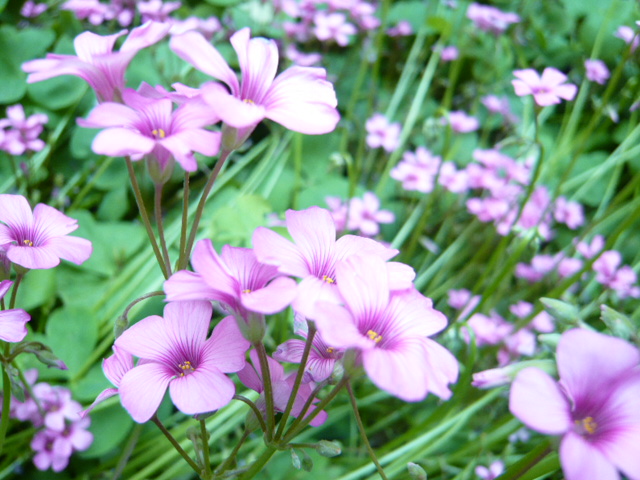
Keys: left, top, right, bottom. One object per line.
{"left": 325, "top": 192, "right": 395, "bottom": 237}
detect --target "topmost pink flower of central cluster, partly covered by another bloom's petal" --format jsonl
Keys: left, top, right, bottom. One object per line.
{"left": 253, "top": 207, "right": 415, "bottom": 316}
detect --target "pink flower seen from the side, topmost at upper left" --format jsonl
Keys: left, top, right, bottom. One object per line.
{"left": 22, "top": 22, "right": 170, "bottom": 102}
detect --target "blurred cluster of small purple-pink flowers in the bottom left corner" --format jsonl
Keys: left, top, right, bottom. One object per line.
{"left": 11, "top": 370, "right": 93, "bottom": 472}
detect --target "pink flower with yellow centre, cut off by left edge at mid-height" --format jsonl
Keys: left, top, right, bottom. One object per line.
{"left": 0, "top": 194, "right": 92, "bottom": 269}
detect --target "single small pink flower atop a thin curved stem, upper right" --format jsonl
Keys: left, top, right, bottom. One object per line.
{"left": 511, "top": 67, "right": 578, "bottom": 107}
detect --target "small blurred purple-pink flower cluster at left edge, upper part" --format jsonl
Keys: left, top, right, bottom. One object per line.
{"left": 0, "top": 104, "right": 49, "bottom": 155}
